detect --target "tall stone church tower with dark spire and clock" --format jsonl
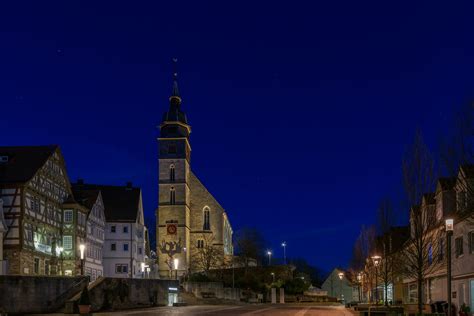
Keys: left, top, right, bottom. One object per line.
{"left": 156, "top": 59, "right": 191, "bottom": 278}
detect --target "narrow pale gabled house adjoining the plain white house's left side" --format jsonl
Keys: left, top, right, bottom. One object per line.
{"left": 72, "top": 184, "right": 105, "bottom": 282}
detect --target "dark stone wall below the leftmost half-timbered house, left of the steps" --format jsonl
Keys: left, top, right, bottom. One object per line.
{"left": 0, "top": 275, "right": 88, "bottom": 314}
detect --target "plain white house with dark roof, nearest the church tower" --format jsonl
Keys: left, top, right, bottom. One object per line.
{"left": 78, "top": 183, "right": 148, "bottom": 278}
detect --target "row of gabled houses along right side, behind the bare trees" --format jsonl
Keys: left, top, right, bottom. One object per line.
{"left": 338, "top": 165, "right": 474, "bottom": 309}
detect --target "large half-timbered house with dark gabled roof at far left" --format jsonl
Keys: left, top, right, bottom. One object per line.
{"left": 0, "top": 146, "right": 80, "bottom": 275}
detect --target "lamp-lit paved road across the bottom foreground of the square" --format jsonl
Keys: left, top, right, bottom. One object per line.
{"left": 94, "top": 304, "right": 354, "bottom": 316}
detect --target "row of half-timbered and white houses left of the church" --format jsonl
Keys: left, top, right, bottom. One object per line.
{"left": 0, "top": 146, "right": 149, "bottom": 281}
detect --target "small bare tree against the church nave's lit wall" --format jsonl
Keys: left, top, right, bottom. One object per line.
{"left": 191, "top": 233, "right": 223, "bottom": 275}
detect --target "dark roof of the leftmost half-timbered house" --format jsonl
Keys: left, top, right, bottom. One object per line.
{"left": 0, "top": 145, "right": 59, "bottom": 184}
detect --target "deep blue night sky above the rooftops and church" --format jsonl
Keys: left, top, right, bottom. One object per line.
{"left": 0, "top": 1, "right": 474, "bottom": 269}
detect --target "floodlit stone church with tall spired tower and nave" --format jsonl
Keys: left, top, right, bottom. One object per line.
{"left": 156, "top": 68, "right": 233, "bottom": 278}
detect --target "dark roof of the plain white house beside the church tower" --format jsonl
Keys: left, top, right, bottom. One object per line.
{"left": 73, "top": 182, "right": 141, "bottom": 222}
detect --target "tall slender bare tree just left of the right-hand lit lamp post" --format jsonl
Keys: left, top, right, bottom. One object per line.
{"left": 402, "top": 132, "right": 441, "bottom": 314}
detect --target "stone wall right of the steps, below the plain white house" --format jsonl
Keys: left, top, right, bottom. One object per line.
{"left": 65, "top": 278, "right": 179, "bottom": 313}
